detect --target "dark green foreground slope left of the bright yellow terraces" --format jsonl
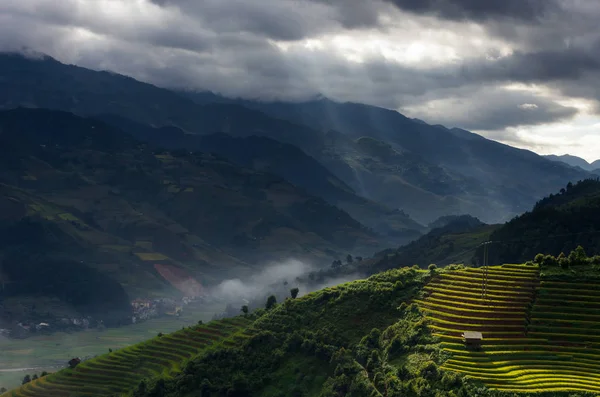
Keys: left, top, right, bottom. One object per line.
{"left": 3, "top": 268, "right": 429, "bottom": 397}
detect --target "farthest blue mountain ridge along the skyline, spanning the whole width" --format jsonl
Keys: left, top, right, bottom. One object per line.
{"left": 0, "top": 54, "right": 590, "bottom": 224}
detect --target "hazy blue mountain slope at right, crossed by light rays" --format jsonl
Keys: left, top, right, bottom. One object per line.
{"left": 187, "top": 93, "right": 589, "bottom": 223}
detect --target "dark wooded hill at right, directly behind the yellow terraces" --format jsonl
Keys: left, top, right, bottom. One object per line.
{"left": 368, "top": 178, "right": 600, "bottom": 273}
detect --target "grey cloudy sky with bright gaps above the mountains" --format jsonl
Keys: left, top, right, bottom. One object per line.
{"left": 0, "top": 0, "right": 600, "bottom": 160}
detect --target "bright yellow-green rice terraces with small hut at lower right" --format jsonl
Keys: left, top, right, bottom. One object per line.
{"left": 418, "top": 265, "right": 600, "bottom": 393}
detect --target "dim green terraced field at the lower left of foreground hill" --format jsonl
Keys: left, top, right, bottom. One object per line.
{"left": 0, "top": 317, "right": 252, "bottom": 397}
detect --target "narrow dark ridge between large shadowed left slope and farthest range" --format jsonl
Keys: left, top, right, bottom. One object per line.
{"left": 99, "top": 115, "right": 426, "bottom": 243}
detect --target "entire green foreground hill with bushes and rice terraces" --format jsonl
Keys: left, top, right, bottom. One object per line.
{"left": 2, "top": 256, "right": 600, "bottom": 397}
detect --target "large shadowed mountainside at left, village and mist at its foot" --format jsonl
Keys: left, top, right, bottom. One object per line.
{"left": 0, "top": 109, "right": 381, "bottom": 328}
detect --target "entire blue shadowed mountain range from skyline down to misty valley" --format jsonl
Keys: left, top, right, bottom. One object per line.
{"left": 0, "top": 53, "right": 592, "bottom": 319}
